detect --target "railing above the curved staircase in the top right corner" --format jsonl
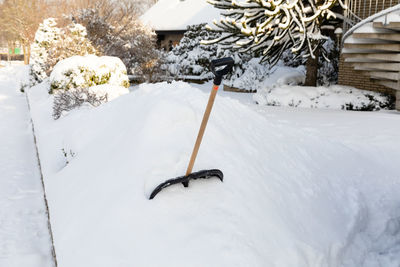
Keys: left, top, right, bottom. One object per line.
{"left": 343, "top": 0, "right": 400, "bottom": 32}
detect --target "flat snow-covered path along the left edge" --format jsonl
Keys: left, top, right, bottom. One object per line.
{"left": 0, "top": 67, "right": 53, "bottom": 267}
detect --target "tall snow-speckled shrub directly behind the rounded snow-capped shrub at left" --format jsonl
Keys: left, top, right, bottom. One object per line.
{"left": 31, "top": 18, "right": 97, "bottom": 82}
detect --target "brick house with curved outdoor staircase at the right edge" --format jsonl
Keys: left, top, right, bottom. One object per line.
{"left": 339, "top": 0, "right": 400, "bottom": 110}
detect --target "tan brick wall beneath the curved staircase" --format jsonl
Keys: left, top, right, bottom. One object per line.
{"left": 339, "top": 54, "right": 395, "bottom": 96}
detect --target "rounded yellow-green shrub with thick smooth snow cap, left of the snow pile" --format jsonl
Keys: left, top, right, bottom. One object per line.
{"left": 50, "top": 55, "right": 129, "bottom": 93}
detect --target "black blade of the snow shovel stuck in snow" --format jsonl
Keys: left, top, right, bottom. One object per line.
{"left": 150, "top": 169, "right": 224, "bottom": 199}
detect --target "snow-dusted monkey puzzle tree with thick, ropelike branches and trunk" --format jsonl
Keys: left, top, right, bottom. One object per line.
{"left": 204, "top": 0, "right": 345, "bottom": 85}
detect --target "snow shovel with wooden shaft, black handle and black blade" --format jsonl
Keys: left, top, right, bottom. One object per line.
{"left": 150, "top": 57, "right": 234, "bottom": 199}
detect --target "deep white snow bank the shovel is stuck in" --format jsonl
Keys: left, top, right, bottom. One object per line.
{"left": 29, "top": 78, "right": 400, "bottom": 267}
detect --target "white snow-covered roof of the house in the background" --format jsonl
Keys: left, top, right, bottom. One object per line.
{"left": 140, "top": 0, "right": 220, "bottom": 31}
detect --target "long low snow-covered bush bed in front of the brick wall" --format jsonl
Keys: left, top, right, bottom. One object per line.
{"left": 253, "top": 83, "right": 394, "bottom": 111}
